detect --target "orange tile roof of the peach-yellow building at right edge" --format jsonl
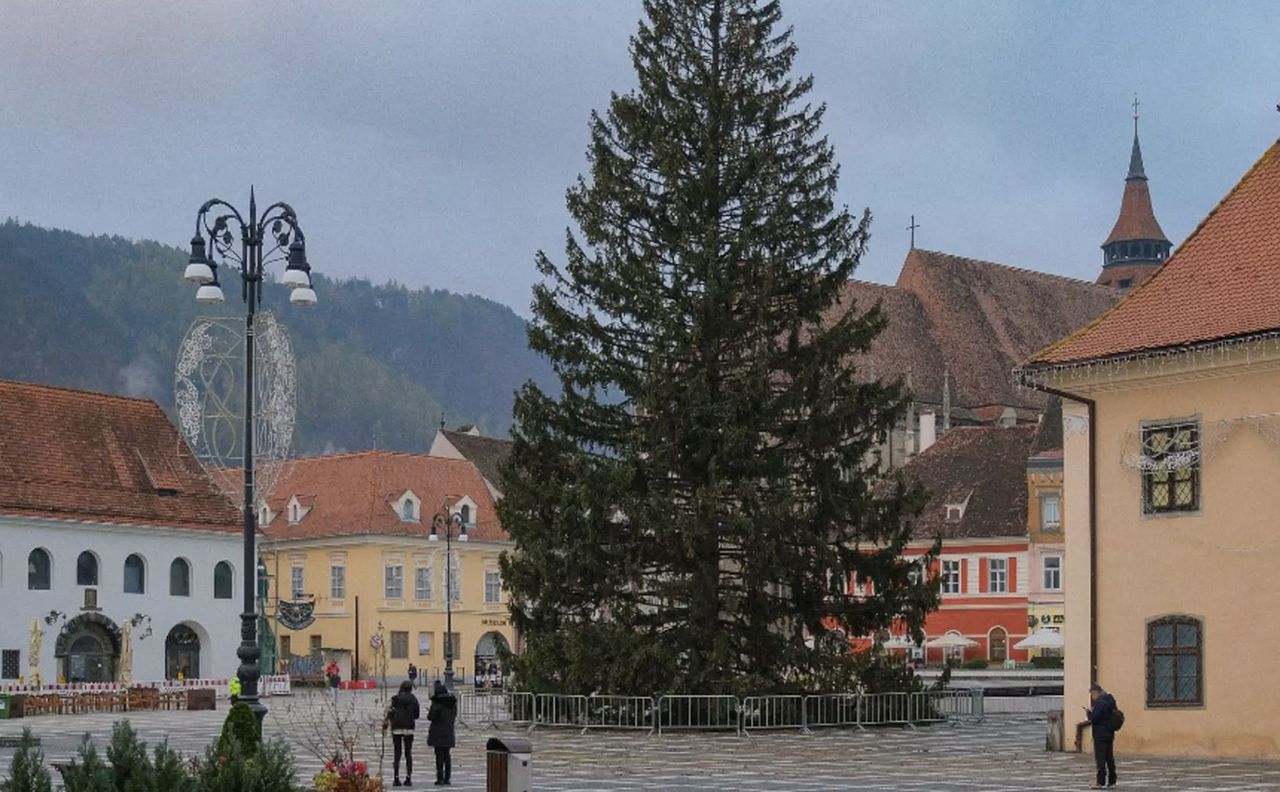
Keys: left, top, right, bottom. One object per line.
{"left": 1027, "top": 141, "right": 1280, "bottom": 368}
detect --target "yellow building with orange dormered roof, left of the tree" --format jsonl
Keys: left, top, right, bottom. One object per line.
{"left": 259, "top": 450, "right": 516, "bottom": 685}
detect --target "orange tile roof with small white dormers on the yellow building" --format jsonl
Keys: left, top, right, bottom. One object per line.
{"left": 257, "top": 450, "right": 509, "bottom": 541}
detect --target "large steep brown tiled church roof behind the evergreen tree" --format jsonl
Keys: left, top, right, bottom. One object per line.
{"left": 841, "top": 248, "right": 1119, "bottom": 408}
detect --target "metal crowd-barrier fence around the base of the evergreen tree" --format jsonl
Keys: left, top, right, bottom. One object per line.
{"left": 458, "top": 688, "right": 984, "bottom": 734}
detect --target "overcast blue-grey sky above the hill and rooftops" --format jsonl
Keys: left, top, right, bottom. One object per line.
{"left": 0, "top": 0, "right": 1280, "bottom": 315}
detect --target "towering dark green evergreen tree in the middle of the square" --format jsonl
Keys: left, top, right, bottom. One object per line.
{"left": 500, "top": 0, "right": 937, "bottom": 692}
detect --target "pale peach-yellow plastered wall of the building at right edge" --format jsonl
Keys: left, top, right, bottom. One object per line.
{"left": 1044, "top": 340, "right": 1280, "bottom": 759}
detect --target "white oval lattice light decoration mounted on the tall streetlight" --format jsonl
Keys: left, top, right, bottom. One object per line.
{"left": 174, "top": 313, "right": 297, "bottom": 508}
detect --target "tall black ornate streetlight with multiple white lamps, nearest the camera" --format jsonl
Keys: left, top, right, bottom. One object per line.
{"left": 184, "top": 188, "right": 316, "bottom": 722}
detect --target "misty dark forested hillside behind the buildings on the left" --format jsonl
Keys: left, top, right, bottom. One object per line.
{"left": 0, "top": 220, "right": 550, "bottom": 455}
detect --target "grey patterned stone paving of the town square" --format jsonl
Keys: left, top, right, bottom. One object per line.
{"left": 0, "top": 692, "right": 1280, "bottom": 792}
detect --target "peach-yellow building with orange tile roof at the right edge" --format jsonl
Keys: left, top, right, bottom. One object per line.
{"left": 1021, "top": 143, "right": 1280, "bottom": 759}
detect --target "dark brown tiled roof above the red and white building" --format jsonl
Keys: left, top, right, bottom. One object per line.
{"left": 902, "top": 426, "right": 1036, "bottom": 540}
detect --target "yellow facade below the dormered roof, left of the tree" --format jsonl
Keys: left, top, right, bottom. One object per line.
{"left": 261, "top": 535, "right": 516, "bottom": 682}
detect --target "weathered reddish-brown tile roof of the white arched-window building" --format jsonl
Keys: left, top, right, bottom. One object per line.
{"left": 0, "top": 380, "right": 241, "bottom": 531}
